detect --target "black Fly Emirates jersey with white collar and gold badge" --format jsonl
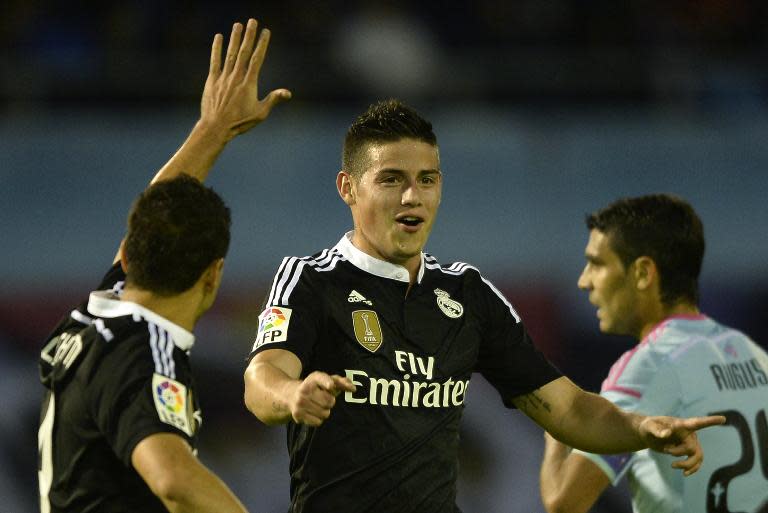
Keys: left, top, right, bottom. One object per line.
{"left": 251, "top": 234, "right": 560, "bottom": 513}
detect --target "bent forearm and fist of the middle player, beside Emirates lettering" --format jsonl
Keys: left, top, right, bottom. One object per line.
{"left": 244, "top": 349, "right": 355, "bottom": 426}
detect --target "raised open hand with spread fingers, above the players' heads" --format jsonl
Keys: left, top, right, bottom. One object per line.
{"left": 200, "top": 19, "right": 291, "bottom": 140}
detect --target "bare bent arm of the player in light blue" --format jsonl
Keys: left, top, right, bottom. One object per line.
{"left": 539, "top": 433, "right": 610, "bottom": 513}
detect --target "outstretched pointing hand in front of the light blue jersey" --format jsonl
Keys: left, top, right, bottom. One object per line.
{"left": 640, "top": 415, "right": 725, "bottom": 476}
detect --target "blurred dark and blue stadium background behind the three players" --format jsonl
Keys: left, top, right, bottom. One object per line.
{"left": 0, "top": 0, "right": 768, "bottom": 513}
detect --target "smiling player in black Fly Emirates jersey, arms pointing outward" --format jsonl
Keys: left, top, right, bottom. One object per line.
{"left": 245, "top": 100, "right": 723, "bottom": 513}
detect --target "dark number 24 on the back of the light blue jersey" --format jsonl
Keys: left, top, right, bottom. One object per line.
{"left": 707, "top": 410, "right": 768, "bottom": 513}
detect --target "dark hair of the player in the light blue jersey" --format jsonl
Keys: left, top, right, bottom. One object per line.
{"left": 587, "top": 194, "right": 705, "bottom": 306}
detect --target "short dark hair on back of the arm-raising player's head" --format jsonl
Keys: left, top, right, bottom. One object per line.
{"left": 123, "top": 174, "right": 231, "bottom": 296}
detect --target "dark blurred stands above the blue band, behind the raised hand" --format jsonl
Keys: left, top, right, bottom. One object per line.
{"left": 0, "top": 0, "right": 768, "bottom": 108}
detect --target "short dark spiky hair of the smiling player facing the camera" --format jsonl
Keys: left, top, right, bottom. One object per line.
{"left": 341, "top": 99, "right": 437, "bottom": 176}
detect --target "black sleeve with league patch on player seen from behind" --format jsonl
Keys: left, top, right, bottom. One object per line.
{"left": 87, "top": 339, "right": 196, "bottom": 466}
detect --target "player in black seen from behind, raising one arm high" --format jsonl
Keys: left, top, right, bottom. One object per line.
{"left": 38, "top": 20, "right": 290, "bottom": 513}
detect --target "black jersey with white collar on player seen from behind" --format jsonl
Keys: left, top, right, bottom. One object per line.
{"left": 38, "top": 265, "right": 202, "bottom": 513}
